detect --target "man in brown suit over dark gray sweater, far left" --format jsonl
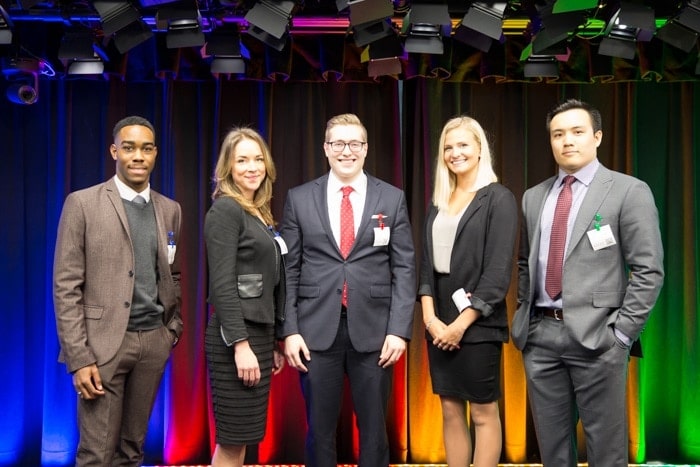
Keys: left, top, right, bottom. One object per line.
{"left": 54, "top": 117, "right": 182, "bottom": 466}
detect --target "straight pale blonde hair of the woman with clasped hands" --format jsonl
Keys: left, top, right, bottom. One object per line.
{"left": 433, "top": 115, "right": 498, "bottom": 209}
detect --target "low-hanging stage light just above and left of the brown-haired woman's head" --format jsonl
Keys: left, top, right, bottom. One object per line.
{"left": 204, "top": 25, "right": 250, "bottom": 76}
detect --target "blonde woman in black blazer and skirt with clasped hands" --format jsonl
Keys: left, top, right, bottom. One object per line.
{"left": 418, "top": 117, "right": 518, "bottom": 466}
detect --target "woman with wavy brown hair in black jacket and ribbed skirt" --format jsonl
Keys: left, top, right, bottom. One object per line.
{"left": 204, "top": 128, "right": 285, "bottom": 467}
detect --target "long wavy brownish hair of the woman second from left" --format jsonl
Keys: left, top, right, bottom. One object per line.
{"left": 211, "top": 127, "right": 277, "bottom": 225}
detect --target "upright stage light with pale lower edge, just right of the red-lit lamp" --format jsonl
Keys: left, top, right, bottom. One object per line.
{"left": 402, "top": 3, "right": 452, "bottom": 55}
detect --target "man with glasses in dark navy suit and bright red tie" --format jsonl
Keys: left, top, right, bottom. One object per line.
{"left": 281, "top": 114, "right": 416, "bottom": 467}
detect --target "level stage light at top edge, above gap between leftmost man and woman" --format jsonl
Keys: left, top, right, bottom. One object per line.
{"left": 156, "top": 0, "right": 205, "bottom": 49}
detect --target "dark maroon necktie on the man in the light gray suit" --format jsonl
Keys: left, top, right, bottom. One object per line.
{"left": 544, "top": 175, "right": 576, "bottom": 299}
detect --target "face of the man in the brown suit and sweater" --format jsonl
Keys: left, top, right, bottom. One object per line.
{"left": 109, "top": 125, "right": 158, "bottom": 192}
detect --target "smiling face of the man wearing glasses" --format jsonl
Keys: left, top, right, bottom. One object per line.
{"left": 323, "top": 125, "right": 367, "bottom": 184}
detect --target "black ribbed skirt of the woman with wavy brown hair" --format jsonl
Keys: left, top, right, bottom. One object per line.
{"left": 204, "top": 314, "right": 275, "bottom": 445}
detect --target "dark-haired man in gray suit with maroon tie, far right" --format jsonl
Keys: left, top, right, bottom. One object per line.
{"left": 512, "top": 99, "right": 663, "bottom": 467}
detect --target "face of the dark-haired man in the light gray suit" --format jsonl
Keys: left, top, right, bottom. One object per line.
{"left": 549, "top": 109, "right": 603, "bottom": 174}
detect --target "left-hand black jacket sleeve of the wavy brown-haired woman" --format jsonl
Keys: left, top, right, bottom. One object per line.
{"left": 204, "top": 198, "right": 248, "bottom": 345}
